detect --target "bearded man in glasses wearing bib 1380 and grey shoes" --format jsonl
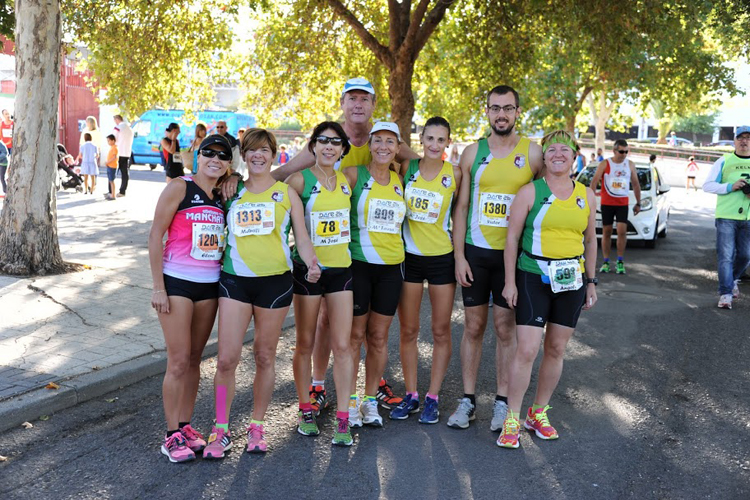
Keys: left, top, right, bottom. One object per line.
{"left": 448, "top": 85, "right": 542, "bottom": 431}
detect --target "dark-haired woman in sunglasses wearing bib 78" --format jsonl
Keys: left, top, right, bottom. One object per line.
{"left": 287, "top": 122, "right": 354, "bottom": 446}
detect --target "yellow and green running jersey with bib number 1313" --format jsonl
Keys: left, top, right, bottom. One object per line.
{"left": 223, "top": 181, "right": 292, "bottom": 277}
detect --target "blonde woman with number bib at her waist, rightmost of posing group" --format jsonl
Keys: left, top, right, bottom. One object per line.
{"left": 497, "top": 130, "right": 597, "bottom": 448}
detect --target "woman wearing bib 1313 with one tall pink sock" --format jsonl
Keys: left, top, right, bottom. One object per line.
{"left": 203, "top": 129, "right": 320, "bottom": 458}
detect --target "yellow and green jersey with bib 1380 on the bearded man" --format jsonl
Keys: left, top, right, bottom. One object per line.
{"left": 464, "top": 137, "right": 534, "bottom": 250}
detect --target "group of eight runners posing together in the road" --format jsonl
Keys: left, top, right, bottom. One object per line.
{"left": 149, "top": 78, "right": 596, "bottom": 462}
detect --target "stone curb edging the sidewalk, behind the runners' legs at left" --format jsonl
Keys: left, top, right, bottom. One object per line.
{"left": 0, "top": 310, "right": 294, "bottom": 432}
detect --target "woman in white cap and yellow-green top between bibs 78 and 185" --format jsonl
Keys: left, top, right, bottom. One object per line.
{"left": 344, "top": 122, "right": 406, "bottom": 427}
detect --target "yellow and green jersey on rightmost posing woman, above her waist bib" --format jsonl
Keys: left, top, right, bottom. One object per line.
{"left": 518, "top": 179, "right": 591, "bottom": 275}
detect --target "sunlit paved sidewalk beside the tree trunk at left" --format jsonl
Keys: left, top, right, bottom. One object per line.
{"left": 0, "top": 166, "right": 293, "bottom": 432}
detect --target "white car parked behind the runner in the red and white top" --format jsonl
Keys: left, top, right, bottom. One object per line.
{"left": 576, "top": 164, "right": 671, "bottom": 248}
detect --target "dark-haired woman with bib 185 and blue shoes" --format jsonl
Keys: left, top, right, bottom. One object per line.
{"left": 390, "top": 116, "right": 461, "bottom": 424}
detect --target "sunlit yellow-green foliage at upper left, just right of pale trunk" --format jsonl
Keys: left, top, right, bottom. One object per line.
{"left": 63, "top": 0, "right": 244, "bottom": 115}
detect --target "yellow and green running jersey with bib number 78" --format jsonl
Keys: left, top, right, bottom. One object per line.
{"left": 293, "top": 170, "right": 352, "bottom": 267}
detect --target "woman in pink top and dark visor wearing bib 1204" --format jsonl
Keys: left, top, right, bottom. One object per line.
{"left": 148, "top": 135, "right": 232, "bottom": 462}
